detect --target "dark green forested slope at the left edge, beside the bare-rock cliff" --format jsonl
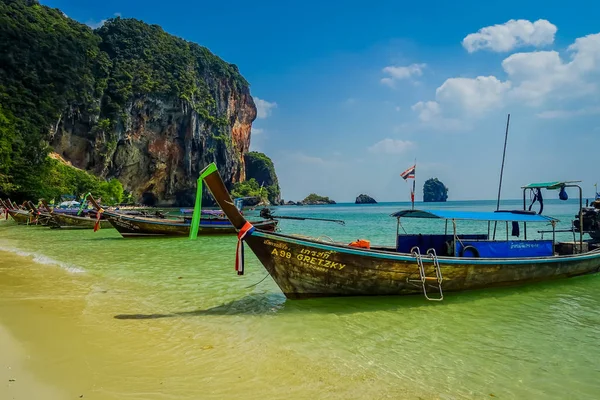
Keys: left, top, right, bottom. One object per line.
{"left": 0, "top": 0, "right": 100, "bottom": 197}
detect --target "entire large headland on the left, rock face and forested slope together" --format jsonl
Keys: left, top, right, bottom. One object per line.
{"left": 0, "top": 0, "right": 279, "bottom": 205}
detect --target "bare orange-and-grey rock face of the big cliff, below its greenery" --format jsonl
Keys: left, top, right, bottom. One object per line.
{"left": 51, "top": 91, "right": 256, "bottom": 205}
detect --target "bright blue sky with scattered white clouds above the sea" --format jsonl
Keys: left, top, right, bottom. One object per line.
{"left": 42, "top": 0, "right": 600, "bottom": 202}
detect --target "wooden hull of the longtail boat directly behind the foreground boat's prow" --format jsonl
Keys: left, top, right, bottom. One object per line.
{"left": 103, "top": 211, "right": 277, "bottom": 237}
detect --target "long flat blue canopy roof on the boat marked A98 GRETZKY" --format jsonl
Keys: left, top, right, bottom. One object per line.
{"left": 392, "top": 210, "right": 558, "bottom": 222}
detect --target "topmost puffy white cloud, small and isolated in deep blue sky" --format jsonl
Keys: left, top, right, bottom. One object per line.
{"left": 462, "top": 19, "right": 557, "bottom": 53}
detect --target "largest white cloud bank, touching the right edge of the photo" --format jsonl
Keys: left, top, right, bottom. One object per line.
{"left": 413, "top": 33, "right": 600, "bottom": 121}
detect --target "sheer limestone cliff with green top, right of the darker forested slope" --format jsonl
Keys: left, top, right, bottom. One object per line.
{"left": 50, "top": 18, "right": 256, "bottom": 206}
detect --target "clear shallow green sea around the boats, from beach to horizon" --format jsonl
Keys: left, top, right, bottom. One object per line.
{"left": 0, "top": 201, "right": 600, "bottom": 399}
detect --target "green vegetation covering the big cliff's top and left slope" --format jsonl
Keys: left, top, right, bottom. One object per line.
{"left": 0, "top": 0, "right": 248, "bottom": 199}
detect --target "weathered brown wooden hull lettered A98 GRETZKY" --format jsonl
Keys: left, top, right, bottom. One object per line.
{"left": 246, "top": 231, "right": 600, "bottom": 299}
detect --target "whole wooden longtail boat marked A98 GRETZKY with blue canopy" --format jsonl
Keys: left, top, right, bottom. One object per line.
{"left": 201, "top": 164, "right": 600, "bottom": 300}
